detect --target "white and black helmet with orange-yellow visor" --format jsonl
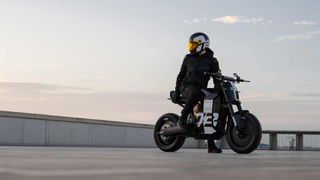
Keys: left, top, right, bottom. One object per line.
{"left": 188, "top": 32, "right": 210, "bottom": 54}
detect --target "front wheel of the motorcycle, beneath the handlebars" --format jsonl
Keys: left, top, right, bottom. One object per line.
{"left": 226, "top": 112, "right": 262, "bottom": 154}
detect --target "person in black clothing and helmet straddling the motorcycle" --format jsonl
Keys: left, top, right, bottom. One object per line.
{"left": 173, "top": 32, "right": 221, "bottom": 153}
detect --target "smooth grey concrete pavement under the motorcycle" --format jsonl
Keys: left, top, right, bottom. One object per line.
{"left": 0, "top": 147, "right": 320, "bottom": 180}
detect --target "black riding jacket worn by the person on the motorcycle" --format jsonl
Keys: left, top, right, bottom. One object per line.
{"left": 176, "top": 48, "right": 220, "bottom": 92}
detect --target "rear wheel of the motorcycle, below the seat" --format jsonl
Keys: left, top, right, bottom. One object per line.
{"left": 153, "top": 113, "right": 186, "bottom": 152}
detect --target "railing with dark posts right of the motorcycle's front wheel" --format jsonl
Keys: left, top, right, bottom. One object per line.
{"left": 259, "top": 130, "right": 320, "bottom": 151}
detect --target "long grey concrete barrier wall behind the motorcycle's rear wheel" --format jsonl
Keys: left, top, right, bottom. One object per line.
{"left": 0, "top": 111, "right": 203, "bottom": 148}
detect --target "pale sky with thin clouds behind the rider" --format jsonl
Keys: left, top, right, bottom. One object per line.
{"left": 0, "top": 0, "right": 320, "bottom": 130}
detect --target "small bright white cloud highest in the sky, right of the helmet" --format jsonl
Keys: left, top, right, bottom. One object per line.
{"left": 211, "top": 16, "right": 272, "bottom": 26}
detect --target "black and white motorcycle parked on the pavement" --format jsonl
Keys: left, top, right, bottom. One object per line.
{"left": 154, "top": 72, "right": 262, "bottom": 154}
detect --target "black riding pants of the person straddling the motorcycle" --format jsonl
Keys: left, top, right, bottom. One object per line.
{"left": 181, "top": 85, "right": 205, "bottom": 120}
